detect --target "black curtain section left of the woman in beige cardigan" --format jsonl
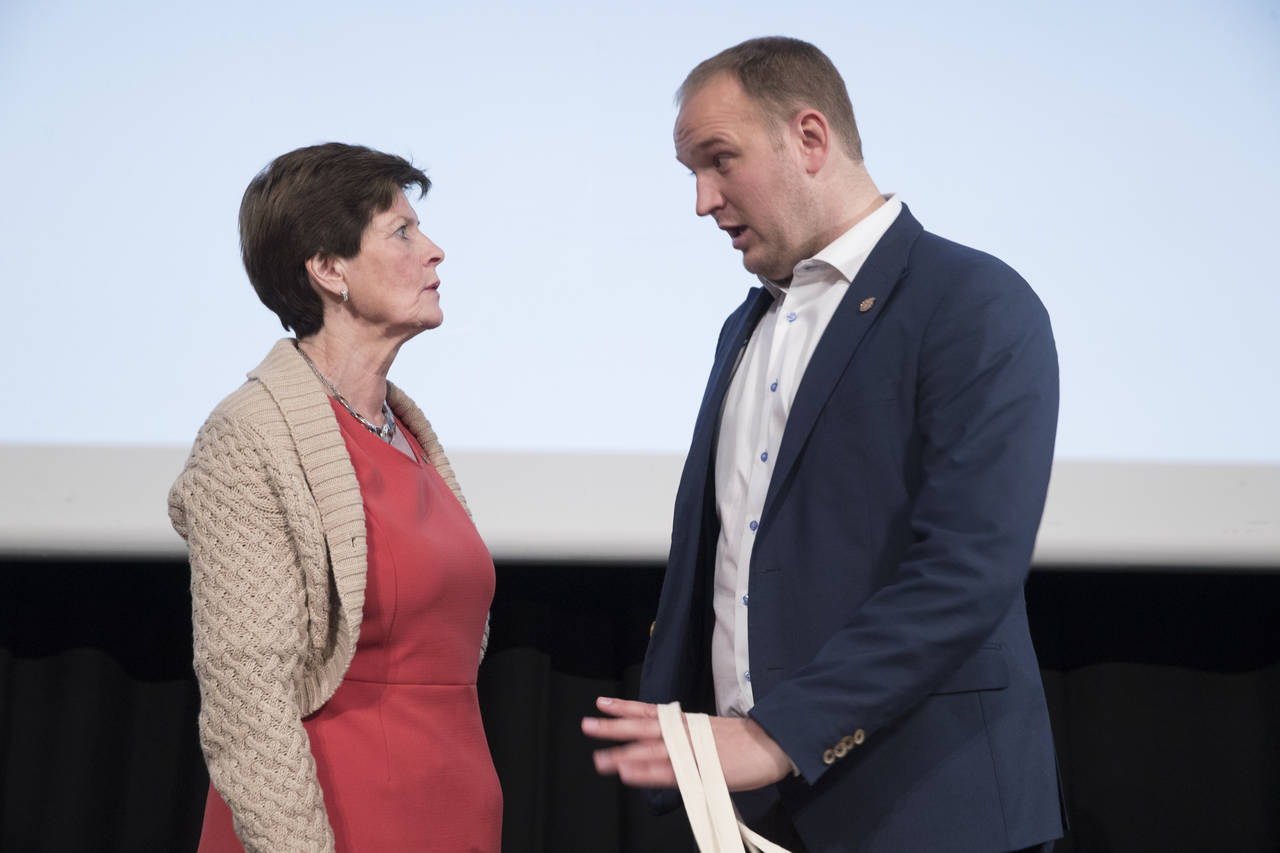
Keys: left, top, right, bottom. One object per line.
{"left": 0, "top": 561, "right": 209, "bottom": 853}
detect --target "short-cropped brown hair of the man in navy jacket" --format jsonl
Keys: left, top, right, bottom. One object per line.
{"left": 676, "top": 36, "right": 863, "bottom": 163}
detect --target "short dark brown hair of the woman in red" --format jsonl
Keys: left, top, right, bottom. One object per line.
{"left": 239, "top": 142, "right": 431, "bottom": 338}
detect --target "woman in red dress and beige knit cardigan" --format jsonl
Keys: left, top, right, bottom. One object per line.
{"left": 169, "top": 143, "right": 502, "bottom": 853}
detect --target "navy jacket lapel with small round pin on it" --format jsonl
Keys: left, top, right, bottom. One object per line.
{"left": 760, "top": 205, "right": 923, "bottom": 523}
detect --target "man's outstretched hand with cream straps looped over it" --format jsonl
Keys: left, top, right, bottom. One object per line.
{"left": 582, "top": 697, "right": 791, "bottom": 790}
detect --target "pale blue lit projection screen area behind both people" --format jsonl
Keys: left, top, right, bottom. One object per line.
{"left": 0, "top": 0, "right": 1280, "bottom": 462}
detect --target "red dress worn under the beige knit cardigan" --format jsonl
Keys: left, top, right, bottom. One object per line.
{"left": 200, "top": 401, "right": 502, "bottom": 853}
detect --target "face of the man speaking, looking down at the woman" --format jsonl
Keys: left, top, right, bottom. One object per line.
{"left": 675, "top": 73, "right": 813, "bottom": 280}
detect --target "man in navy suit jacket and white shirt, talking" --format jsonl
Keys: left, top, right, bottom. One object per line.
{"left": 584, "top": 38, "right": 1062, "bottom": 853}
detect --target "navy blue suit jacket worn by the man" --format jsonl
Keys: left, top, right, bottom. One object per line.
{"left": 640, "top": 207, "right": 1061, "bottom": 853}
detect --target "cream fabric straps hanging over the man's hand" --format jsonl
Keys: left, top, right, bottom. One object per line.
{"left": 658, "top": 702, "right": 787, "bottom": 853}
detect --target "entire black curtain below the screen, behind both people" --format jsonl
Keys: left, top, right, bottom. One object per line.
{"left": 0, "top": 560, "right": 1280, "bottom": 853}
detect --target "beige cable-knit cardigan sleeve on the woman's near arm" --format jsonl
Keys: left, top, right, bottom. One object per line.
{"left": 169, "top": 419, "right": 334, "bottom": 853}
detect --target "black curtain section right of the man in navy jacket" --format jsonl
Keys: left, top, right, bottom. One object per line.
{"left": 1027, "top": 573, "right": 1280, "bottom": 853}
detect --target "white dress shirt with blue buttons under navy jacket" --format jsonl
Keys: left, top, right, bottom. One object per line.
{"left": 712, "top": 196, "right": 902, "bottom": 716}
